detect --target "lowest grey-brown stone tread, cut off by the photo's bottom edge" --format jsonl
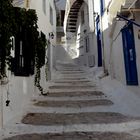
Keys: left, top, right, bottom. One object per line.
{"left": 4, "top": 132, "right": 140, "bottom": 140}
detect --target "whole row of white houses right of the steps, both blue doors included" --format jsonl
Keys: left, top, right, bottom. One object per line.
{"left": 64, "top": 0, "right": 140, "bottom": 93}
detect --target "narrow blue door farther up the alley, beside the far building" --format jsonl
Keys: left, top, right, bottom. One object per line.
{"left": 96, "top": 16, "right": 102, "bottom": 67}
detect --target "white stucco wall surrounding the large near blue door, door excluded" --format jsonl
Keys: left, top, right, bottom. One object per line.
{"left": 102, "top": 0, "right": 140, "bottom": 93}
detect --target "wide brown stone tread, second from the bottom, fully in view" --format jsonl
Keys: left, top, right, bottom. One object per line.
{"left": 22, "top": 112, "right": 139, "bottom": 126}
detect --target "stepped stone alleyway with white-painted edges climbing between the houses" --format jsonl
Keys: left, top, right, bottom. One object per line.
{"left": 3, "top": 63, "right": 140, "bottom": 140}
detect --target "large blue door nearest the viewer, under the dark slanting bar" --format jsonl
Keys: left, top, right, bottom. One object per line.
{"left": 122, "top": 23, "right": 138, "bottom": 85}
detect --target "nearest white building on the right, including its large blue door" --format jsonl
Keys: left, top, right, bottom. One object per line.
{"left": 94, "top": 0, "right": 140, "bottom": 93}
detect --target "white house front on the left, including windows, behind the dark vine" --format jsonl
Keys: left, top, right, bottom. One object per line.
{"left": 0, "top": 0, "right": 56, "bottom": 128}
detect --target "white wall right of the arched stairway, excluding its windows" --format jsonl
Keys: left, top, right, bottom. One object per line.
{"left": 76, "top": 0, "right": 96, "bottom": 66}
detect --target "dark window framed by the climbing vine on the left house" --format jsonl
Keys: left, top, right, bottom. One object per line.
{"left": 12, "top": 28, "right": 34, "bottom": 76}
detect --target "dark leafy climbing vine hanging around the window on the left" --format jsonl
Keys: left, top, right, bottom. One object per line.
{"left": 0, "top": 0, "right": 48, "bottom": 94}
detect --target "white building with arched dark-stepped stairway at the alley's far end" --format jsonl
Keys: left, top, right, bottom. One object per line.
{"left": 64, "top": 0, "right": 95, "bottom": 64}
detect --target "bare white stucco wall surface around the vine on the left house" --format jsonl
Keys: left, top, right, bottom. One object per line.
{"left": 0, "top": 0, "right": 56, "bottom": 128}
